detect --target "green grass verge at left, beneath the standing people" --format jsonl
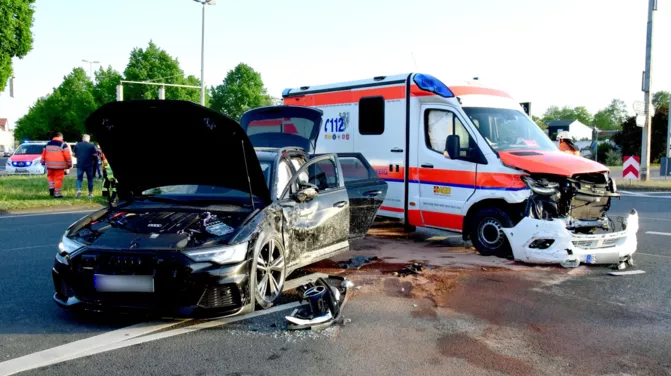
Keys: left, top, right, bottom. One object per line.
{"left": 0, "top": 175, "right": 106, "bottom": 211}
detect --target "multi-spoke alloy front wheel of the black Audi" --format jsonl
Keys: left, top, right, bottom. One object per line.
{"left": 249, "top": 237, "right": 287, "bottom": 309}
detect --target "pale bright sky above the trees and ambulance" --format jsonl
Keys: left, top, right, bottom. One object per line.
{"left": 0, "top": 0, "right": 671, "bottom": 129}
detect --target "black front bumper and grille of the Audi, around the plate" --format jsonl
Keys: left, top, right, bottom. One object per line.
{"left": 52, "top": 251, "right": 252, "bottom": 317}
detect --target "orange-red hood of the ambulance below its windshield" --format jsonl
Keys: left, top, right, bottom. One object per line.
{"left": 499, "top": 150, "right": 608, "bottom": 176}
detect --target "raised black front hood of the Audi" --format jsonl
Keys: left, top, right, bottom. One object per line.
{"left": 85, "top": 100, "right": 270, "bottom": 203}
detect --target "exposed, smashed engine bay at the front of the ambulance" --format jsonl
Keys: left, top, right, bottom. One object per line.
{"left": 523, "top": 173, "right": 620, "bottom": 232}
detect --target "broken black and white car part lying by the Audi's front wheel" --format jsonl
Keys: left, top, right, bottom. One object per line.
{"left": 285, "top": 277, "right": 353, "bottom": 330}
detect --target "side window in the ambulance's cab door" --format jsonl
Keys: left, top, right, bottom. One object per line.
{"left": 424, "top": 110, "right": 471, "bottom": 157}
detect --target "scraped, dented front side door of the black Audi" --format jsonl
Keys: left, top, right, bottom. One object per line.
{"left": 282, "top": 154, "right": 350, "bottom": 266}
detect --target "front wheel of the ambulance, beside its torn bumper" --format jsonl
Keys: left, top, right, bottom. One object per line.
{"left": 471, "top": 208, "right": 513, "bottom": 257}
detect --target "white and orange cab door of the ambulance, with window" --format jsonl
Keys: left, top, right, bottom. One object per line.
{"left": 417, "top": 105, "right": 482, "bottom": 231}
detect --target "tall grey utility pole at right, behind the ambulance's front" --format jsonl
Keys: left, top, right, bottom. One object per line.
{"left": 641, "top": 0, "right": 657, "bottom": 181}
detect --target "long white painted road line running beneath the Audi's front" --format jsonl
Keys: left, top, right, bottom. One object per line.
{"left": 0, "top": 302, "right": 303, "bottom": 376}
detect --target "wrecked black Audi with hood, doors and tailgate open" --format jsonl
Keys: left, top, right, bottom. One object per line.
{"left": 52, "top": 101, "right": 387, "bottom": 316}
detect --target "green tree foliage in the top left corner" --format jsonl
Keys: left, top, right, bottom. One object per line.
{"left": 0, "top": 0, "right": 35, "bottom": 91}
